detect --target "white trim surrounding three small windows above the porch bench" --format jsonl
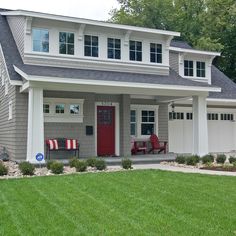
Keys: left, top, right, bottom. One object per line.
{"left": 43, "top": 98, "right": 84, "bottom": 123}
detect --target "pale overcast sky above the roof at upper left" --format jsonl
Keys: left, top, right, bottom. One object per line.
{"left": 0, "top": 0, "right": 119, "bottom": 20}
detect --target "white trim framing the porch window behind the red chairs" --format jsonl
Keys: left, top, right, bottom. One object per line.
{"left": 130, "top": 104, "right": 159, "bottom": 138}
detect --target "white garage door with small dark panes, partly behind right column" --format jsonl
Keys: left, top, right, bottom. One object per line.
{"left": 169, "top": 108, "right": 236, "bottom": 153}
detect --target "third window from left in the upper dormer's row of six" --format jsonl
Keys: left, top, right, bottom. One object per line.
{"left": 84, "top": 35, "right": 98, "bottom": 57}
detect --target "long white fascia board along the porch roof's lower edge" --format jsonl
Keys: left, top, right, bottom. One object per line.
{"left": 28, "top": 76, "right": 221, "bottom": 92}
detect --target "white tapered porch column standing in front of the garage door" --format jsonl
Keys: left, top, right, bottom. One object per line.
{"left": 193, "top": 96, "right": 208, "bottom": 156}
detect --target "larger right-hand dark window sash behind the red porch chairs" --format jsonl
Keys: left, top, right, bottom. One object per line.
{"left": 141, "top": 110, "right": 155, "bottom": 135}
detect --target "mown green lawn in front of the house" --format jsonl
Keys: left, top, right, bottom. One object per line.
{"left": 0, "top": 170, "right": 236, "bottom": 236}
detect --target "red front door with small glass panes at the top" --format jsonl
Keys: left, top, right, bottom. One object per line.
{"left": 97, "top": 106, "right": 115, "bottom": 156}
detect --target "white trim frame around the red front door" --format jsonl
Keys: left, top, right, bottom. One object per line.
{"left": 94, "top": 102, "right": 120, "bottom": 156}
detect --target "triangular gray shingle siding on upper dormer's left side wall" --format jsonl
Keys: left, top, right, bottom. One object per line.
{"left": 7, "top": 16, "right": 25, "bottom": 58}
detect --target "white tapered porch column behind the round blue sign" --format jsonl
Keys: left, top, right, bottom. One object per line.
{"left": 27, "top": 88, "right": 44, "bottom": 163}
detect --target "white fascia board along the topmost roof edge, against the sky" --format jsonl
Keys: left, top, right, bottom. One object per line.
{"left": 0, "top": 10, "right": 180, "bottom": 36}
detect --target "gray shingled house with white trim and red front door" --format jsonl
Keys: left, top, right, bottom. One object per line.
{"left": 0, "top": 9, "right": 236, "bottom": 162}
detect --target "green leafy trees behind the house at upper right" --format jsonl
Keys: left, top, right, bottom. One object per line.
{"left": 110, "top": 0, "right": 236, "bottom": 81}
